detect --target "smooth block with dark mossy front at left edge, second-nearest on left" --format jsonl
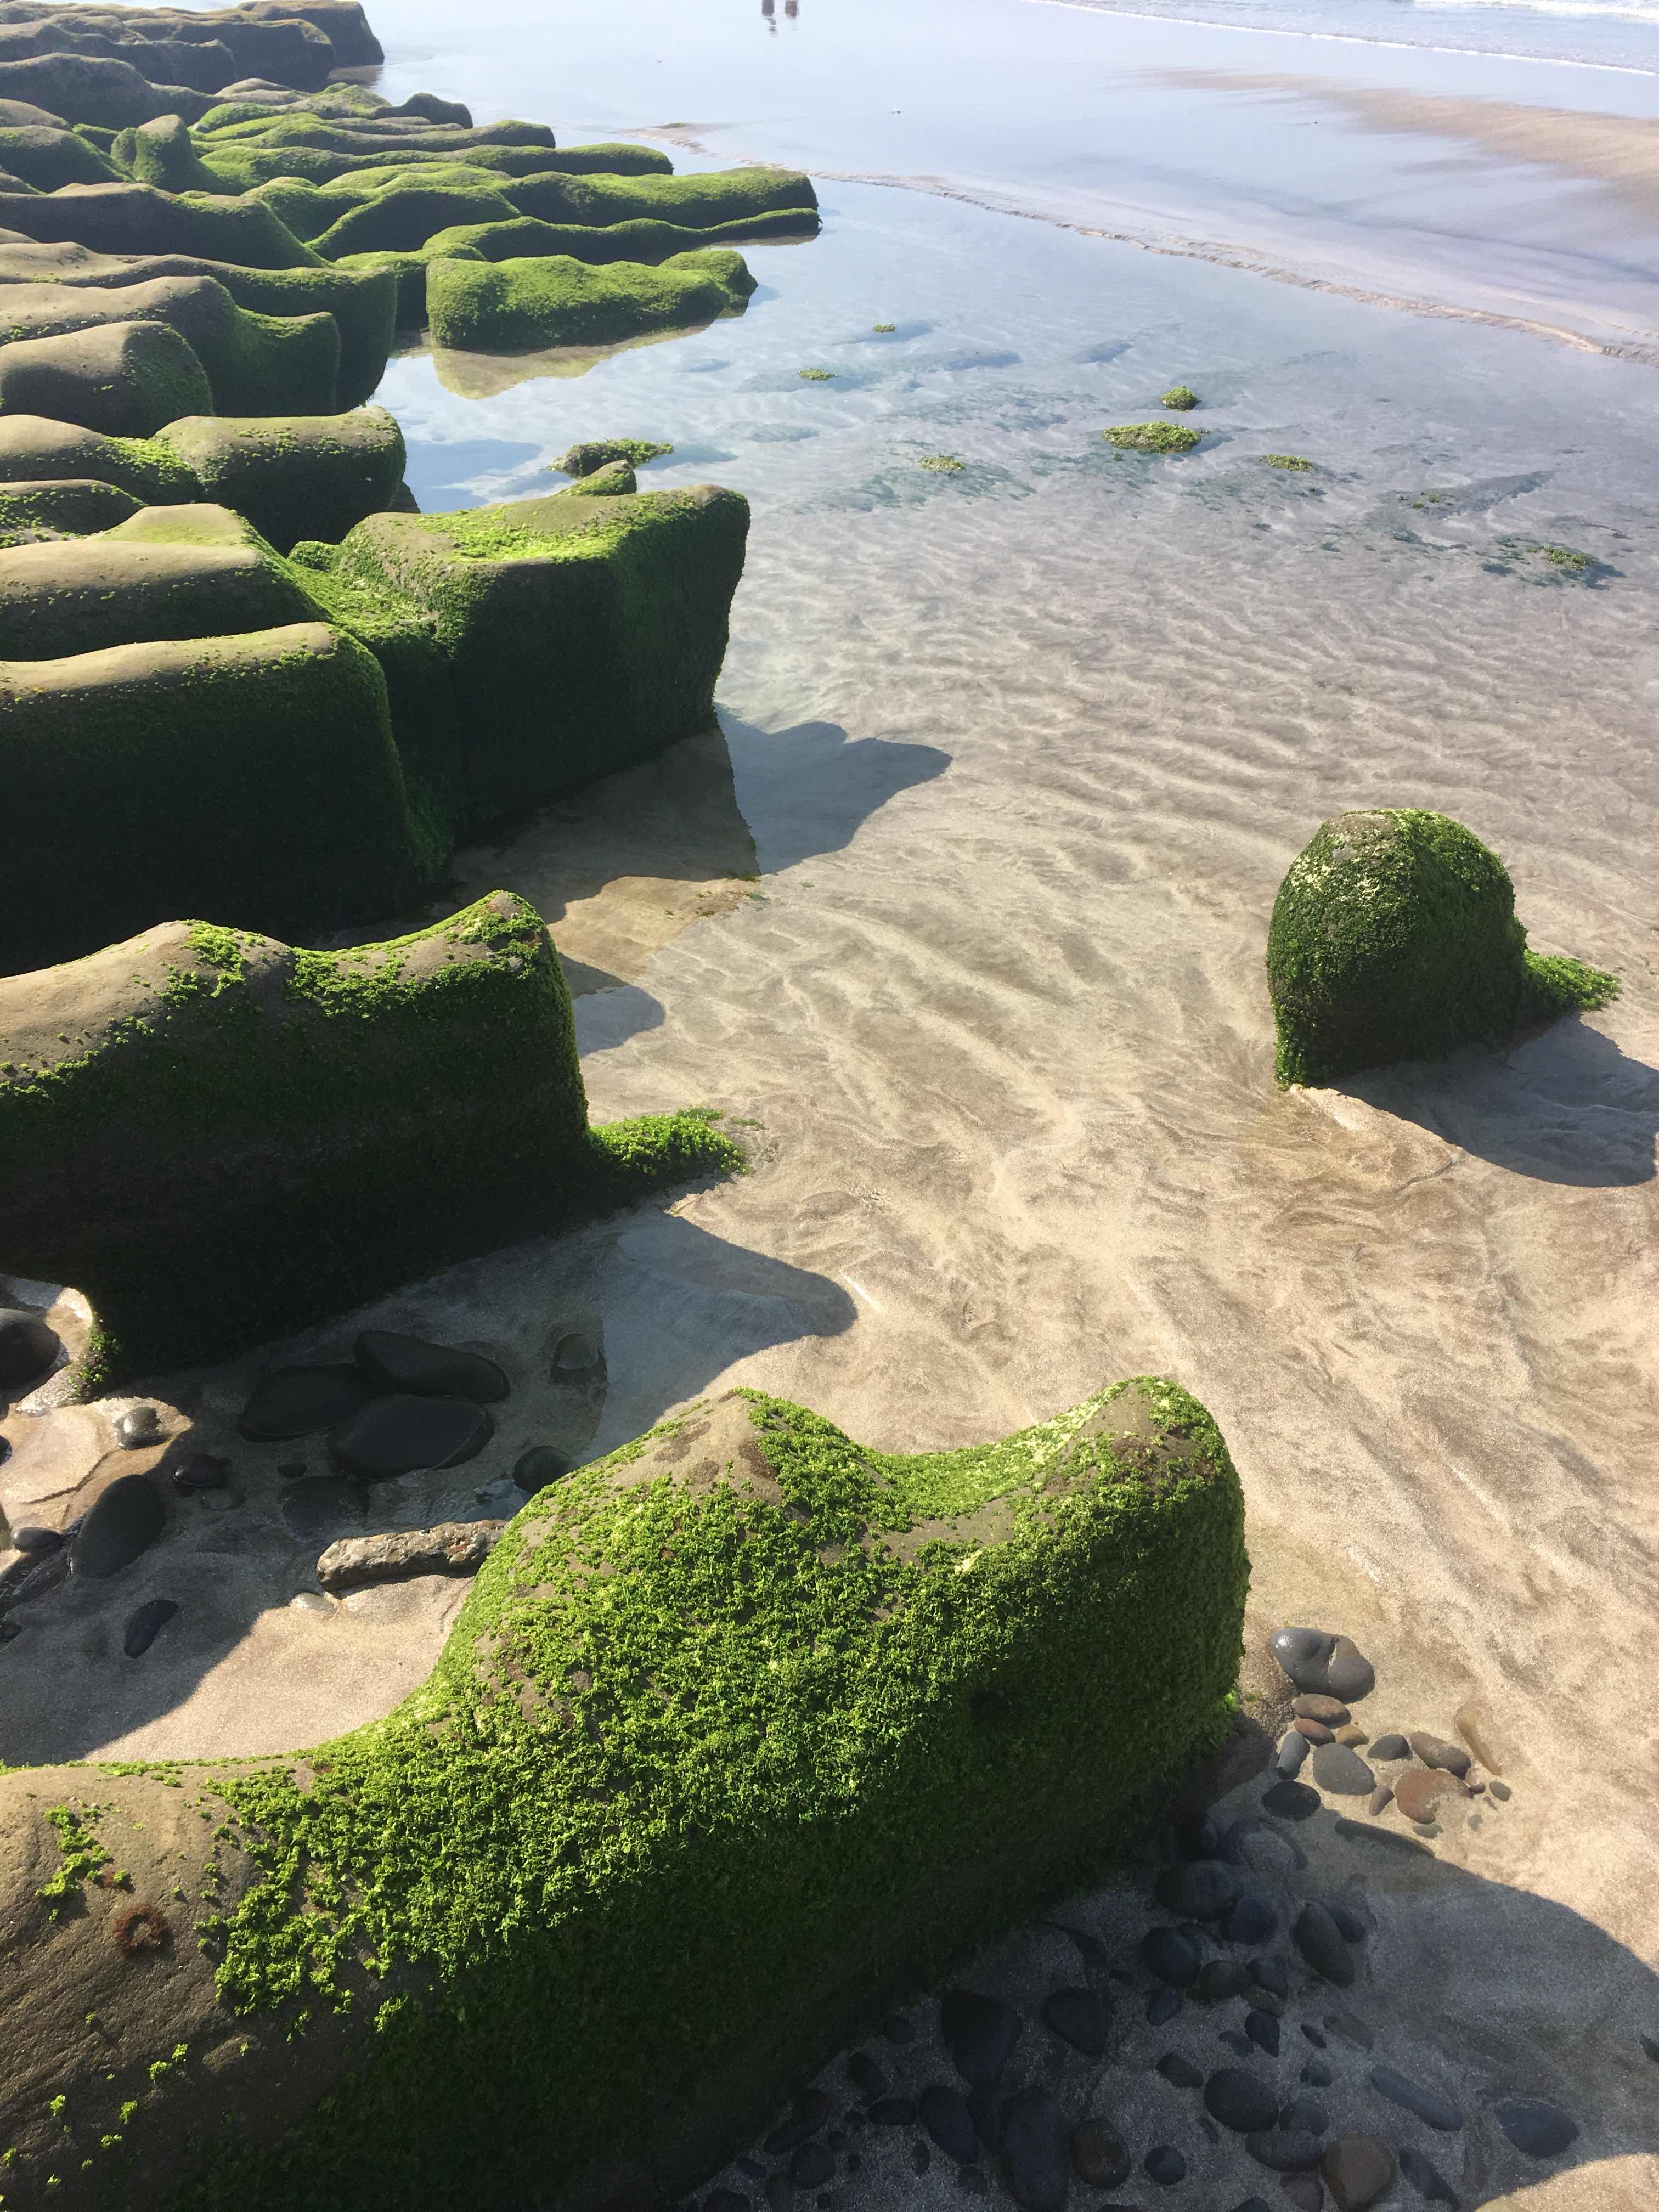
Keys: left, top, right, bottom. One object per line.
{"left": 0, "top": 614, "right": 425, "bottom": 971}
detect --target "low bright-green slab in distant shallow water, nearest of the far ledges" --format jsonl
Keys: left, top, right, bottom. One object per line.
{"left": 427, "top": 248, "right": 754, "bottom": 354}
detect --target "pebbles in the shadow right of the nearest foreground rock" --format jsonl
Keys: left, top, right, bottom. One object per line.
{"left": 684, "top": 1628, "right": 1610, "bottom": 2212}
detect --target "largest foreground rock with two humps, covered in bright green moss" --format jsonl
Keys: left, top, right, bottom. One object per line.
{"left": 0, "top": 1378, "right": 1248, "bottom": 2212}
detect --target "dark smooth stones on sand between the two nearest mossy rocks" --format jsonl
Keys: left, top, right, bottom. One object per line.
{"left": 0, "top": 1312, "right": 600, "bottom": 1659}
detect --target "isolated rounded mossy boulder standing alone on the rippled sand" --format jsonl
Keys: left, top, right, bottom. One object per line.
{"left": 1267, "top": 808, "right": 1619, "bottom": 1084}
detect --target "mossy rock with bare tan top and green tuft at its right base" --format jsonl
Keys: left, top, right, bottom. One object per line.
{"left": 0, "top": 884, "right": 737, "bottom": 1389}
